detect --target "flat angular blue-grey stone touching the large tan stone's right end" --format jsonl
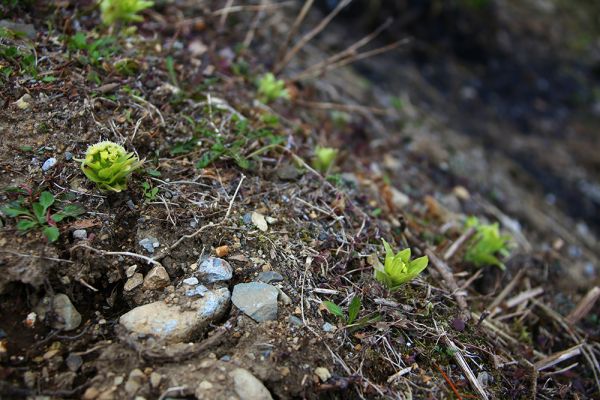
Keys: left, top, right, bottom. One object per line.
{"left": 232, "top": 282, "right": 279, "bottom": 322}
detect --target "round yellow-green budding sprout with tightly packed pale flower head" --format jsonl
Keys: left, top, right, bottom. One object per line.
{"left": 76, "top": 141, "right": 144, "bottom": 192}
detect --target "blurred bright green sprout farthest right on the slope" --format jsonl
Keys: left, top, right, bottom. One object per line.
{"left": 464, "top": 216, "right": 512, "bottom": 271}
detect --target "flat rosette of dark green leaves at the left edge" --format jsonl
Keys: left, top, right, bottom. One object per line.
{"left": 0, "top": 191, "right": 85, "bottom": 242}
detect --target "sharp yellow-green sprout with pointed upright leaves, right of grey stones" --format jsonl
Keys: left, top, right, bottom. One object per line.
{"left": 375, "top": 239, "right": 429, "bottom": 291}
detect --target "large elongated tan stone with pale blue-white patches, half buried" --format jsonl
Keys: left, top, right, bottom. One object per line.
{"left": 119, "top": 288, "right": 230, "bottom": 343}
